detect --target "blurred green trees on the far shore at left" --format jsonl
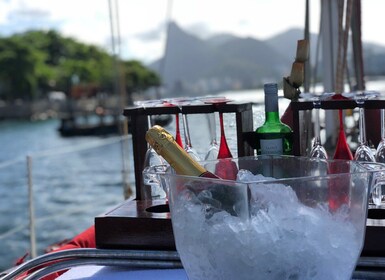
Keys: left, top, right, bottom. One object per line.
{"left": 0, "top": 30, "right": 160, "bottom": 101}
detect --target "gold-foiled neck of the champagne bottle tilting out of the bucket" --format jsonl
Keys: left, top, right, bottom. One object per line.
{"left": 146, "top": 125, "right": 219, "bottom": 178}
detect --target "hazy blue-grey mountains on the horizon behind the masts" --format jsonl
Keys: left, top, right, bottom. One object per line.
{"left": 150, "top": 23, "right": 385, "bottom": 96}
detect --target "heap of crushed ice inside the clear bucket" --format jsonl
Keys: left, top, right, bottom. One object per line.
{"left": 172, "top": 170, "right": 361, "bottom": 279}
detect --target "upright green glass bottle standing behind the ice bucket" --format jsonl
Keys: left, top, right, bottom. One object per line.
{"left": 256, "top": 83, "right": 293, "bottom": 155}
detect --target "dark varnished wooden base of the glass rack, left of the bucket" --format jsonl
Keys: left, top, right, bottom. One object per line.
{"left": 95, "top": 200, "right": 176, "bottom": 250}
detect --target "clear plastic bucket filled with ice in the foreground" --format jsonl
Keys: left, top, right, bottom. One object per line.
{"left": 147, "top": 156, "right": 384, "bottom": 279}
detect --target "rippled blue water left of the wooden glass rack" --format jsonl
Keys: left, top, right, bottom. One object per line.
{"left": 0, "top": 120, "right": 133, "bottom": 270}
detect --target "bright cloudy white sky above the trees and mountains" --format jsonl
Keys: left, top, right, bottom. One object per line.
{"left": 0, "top": 0, "right": 385, "bottom": 63}
